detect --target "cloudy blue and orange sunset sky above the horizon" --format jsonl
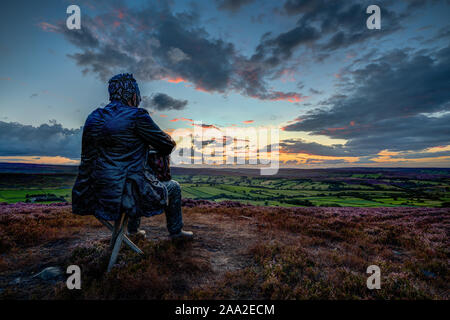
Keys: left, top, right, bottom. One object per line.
{"left": 0, "top": 0, "right": 450, "bottom": 168}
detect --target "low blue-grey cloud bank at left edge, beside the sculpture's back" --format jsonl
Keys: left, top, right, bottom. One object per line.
{"left": 0, "top": 121, "right": 81, "bottom": 158}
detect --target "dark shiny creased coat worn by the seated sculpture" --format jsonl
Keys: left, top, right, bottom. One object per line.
{"left": 72, "top": 101, "right": 175, "bottom": 220}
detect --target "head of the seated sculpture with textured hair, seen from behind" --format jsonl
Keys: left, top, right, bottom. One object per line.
{"left": 108, "top": 73, "right": 141, "bottom": 107}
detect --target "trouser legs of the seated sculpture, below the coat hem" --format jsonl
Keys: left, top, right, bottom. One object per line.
{"left": 128, "top": 180, "right": 183, "bottom": 234}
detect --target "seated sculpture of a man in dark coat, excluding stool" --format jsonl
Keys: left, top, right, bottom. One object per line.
{"left": 72, "top": 74, "right": 193, "bottom": 239}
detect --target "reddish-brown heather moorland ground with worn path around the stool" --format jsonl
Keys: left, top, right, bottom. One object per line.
{"left": 0, "top": 200, "right": 450, "bottom": 299}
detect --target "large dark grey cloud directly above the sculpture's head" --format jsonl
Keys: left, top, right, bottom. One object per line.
{"left": 57, "top": 5, "right": 234, "bottom": 92}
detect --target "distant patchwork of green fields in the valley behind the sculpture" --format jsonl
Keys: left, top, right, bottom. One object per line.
{"left": 0, "top": 173, "right": 450, "bottom": 207}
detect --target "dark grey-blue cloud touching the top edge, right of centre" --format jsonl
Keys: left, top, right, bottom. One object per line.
{"left": 252, "top": 0, "right": 406, "bottom": 67}
